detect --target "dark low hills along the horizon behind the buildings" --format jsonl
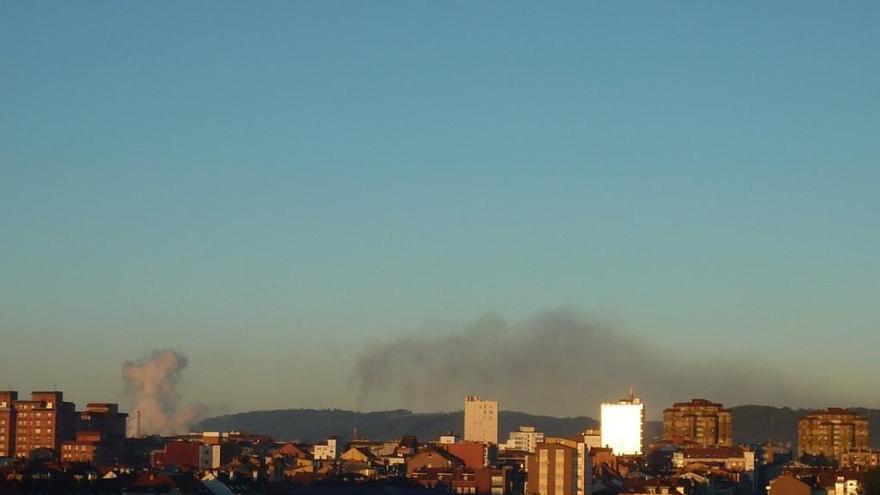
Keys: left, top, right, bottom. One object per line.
{"left": 193, "top": 405, "right": 880, "bottom": 448}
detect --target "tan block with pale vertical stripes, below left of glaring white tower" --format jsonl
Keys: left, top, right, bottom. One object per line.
{"left": 526, "top": 437, "right": 592, "bottom": 495}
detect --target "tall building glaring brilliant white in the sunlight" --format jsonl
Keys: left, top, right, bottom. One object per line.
{"left": 601, "top": 391, "right": 645, "bottom": 455}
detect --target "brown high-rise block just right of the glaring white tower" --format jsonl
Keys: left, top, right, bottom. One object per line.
{"left": 663, "top": 399, "right": 733, "bottom": 447}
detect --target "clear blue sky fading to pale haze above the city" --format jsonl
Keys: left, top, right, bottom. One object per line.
{"left": 0, "top": 1, "right": 880, "bottom": 414}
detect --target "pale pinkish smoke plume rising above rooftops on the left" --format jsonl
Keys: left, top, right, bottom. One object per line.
{"left": 122, "top": 349, "right": 207, "bottom": 435}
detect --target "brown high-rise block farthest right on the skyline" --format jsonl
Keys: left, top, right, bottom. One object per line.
{"left": 798, "top": 407, "right": 869, "bottom": 462}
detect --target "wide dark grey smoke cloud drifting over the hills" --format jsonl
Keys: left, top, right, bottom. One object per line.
{"left": 353, "top": 309, "right": 848, "bottom": 418}
